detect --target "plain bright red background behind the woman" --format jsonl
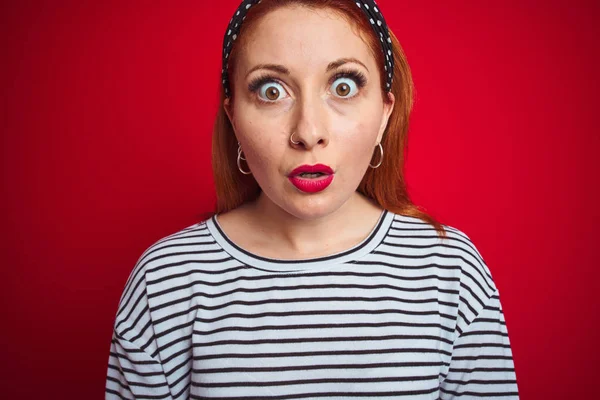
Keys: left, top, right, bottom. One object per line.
{"left": 0, "top": 0, "right": 600, "bottom": 399}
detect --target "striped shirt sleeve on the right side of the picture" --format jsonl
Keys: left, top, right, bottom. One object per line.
{"left": 440, "top": 290, "right": 519, "bottom": 400}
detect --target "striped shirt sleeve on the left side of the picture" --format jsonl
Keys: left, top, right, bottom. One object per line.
{"left": 105, "top": 248, "right": 173, "bottom": 400}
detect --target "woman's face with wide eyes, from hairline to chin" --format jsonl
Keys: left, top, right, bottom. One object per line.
{"left": 224, "top": 6, "right": 394, "bottom": 219}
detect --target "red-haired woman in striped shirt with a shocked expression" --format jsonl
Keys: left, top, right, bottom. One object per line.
{"left": 106, "top": 0, "right": 518, "bottom": 399}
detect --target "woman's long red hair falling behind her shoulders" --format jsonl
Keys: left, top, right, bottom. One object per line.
{"left": 206, "top": 0, "right": 446, "bottom": 237}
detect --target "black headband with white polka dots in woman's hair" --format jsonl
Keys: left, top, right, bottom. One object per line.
{"left": 221, "top": 0, "right": 394, "bottom": 97}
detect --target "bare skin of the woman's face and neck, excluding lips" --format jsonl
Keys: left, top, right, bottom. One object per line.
{"left": 217, "top": 6, "right": 395, "bottom": 259}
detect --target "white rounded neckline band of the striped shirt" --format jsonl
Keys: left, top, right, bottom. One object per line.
{"left": 206, "top": 209, "right": 394, "bottom": 272}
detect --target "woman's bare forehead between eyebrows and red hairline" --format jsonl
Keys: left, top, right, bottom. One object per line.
{"left": 239, "top": 6, "right": 375, "bottom": 73}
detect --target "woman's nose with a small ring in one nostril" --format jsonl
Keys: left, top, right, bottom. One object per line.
{"left": 290, "top": 94, "right": 329, "bottom": 150}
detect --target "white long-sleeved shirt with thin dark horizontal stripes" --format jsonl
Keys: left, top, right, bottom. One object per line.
{"left": 106, "top": 210, "right": 518, "bottom": 400}
